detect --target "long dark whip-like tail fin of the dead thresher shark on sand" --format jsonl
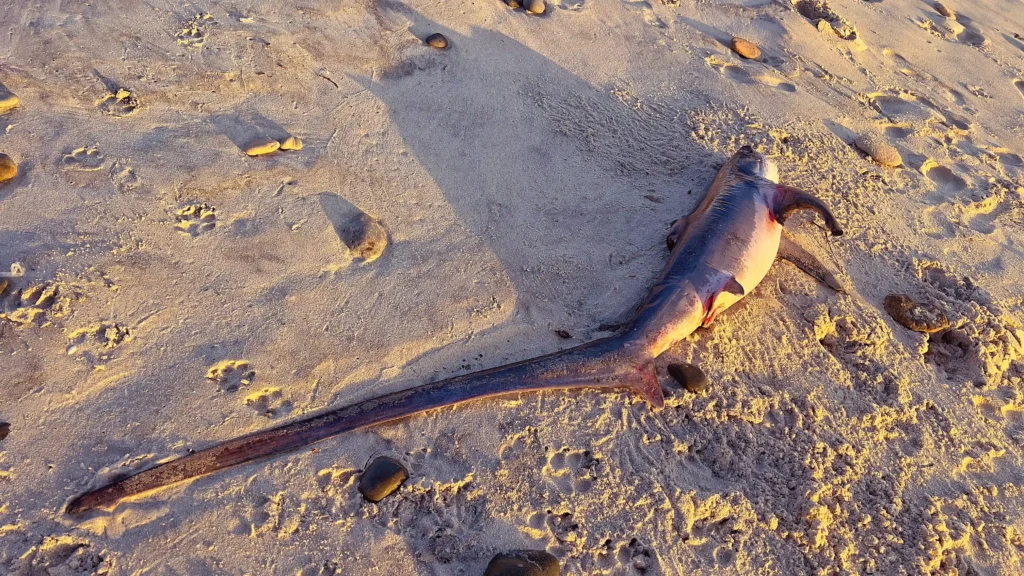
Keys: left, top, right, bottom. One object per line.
{"left": 67, "top": 336, "right": 664, "bottom": 515}
